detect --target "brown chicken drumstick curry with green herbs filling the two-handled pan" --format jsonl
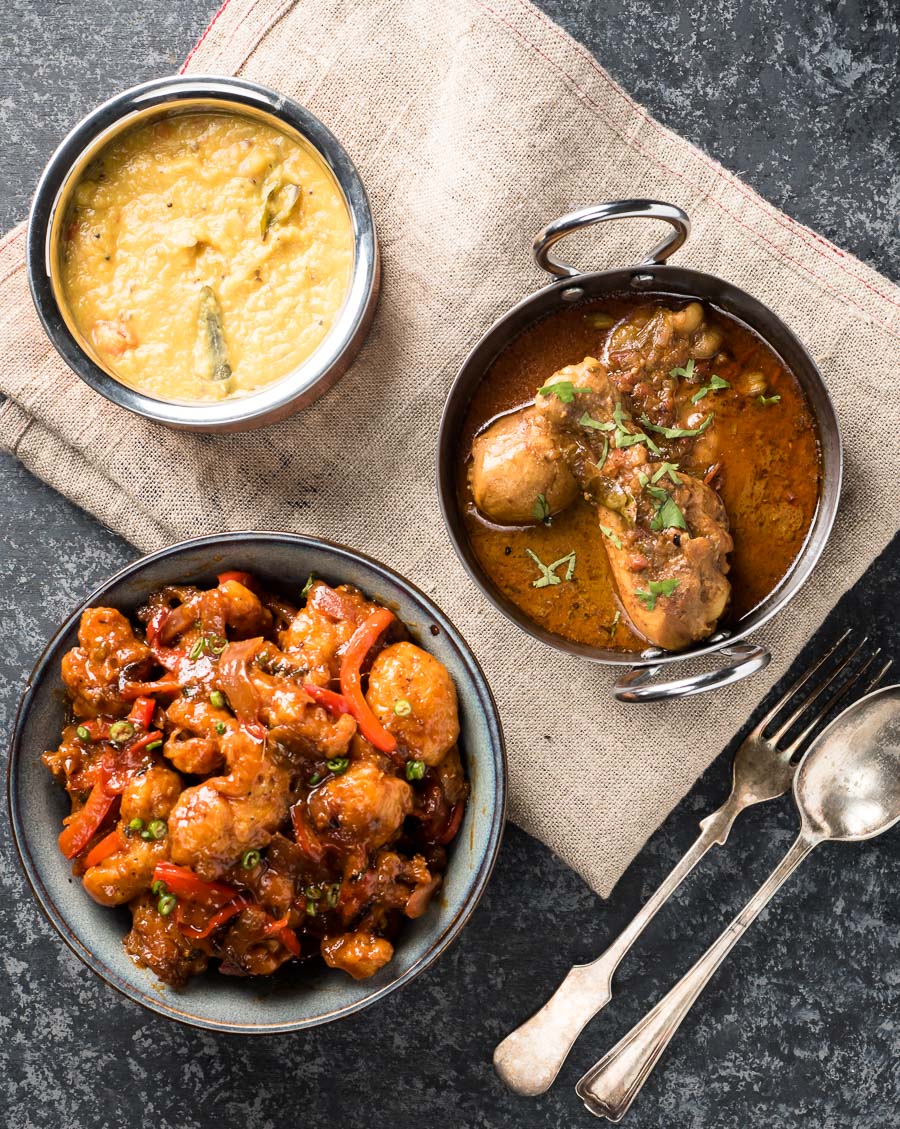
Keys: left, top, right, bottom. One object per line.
{"left": 458, "top": 298, "right": 820, "bottom": 651}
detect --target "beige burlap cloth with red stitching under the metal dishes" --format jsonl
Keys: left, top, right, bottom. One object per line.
{"left": 0, "top": 0, "right": 900, "bottom": 894}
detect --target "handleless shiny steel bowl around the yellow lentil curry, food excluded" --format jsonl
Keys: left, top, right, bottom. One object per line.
{"left": 27, "top": 76, "right": 379, "bottom": 431}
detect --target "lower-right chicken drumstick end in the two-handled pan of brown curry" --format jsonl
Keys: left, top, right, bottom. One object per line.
{"left": 598, "top": 463, "right": 733, "bottom": 650}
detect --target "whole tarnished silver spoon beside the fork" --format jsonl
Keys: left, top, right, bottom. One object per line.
{"left": 575, "top": 685, "right": 900, "bottom": 1121}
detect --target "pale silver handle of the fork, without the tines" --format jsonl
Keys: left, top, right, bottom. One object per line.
{"left": 493, "top": 797, "right": 741, "bottom": 1097}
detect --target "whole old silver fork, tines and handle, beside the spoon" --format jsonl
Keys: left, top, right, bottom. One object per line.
{"left": 493, "top": 630, "right": 891, "bottom": 1096}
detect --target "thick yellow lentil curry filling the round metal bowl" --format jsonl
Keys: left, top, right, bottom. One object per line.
{"left": 61, "top": 113, "right": 353, "bottom": 402}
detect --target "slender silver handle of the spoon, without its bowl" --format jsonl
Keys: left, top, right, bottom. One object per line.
{"left": 575, "top": 831, "right": 821, "bottom": 1121}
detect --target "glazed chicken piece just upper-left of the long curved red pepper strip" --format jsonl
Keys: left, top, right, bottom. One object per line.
{"left": 279, "top": 580, "right": 377, "bottom": 685}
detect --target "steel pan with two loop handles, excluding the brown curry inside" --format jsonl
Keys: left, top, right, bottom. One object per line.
{"left": 437, "top": 200, "right": 842, "bottom": 701}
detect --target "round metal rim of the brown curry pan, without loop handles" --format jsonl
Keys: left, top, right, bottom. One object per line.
{"left": 435, "top": 262, "right": 844, "bottom": 668}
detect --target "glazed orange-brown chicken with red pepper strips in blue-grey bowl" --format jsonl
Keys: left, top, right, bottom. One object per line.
{"left": 44, "top": 572, "right": 469, "bottom": 986}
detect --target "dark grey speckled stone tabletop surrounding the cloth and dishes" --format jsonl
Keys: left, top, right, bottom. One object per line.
{"left": 0, "top": 0, "right": 900, "bottom": 1129}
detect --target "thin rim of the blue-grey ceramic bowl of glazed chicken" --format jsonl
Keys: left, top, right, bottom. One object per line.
{"left": 7, "top": 530, "right": 508, "bottom": 1035}
